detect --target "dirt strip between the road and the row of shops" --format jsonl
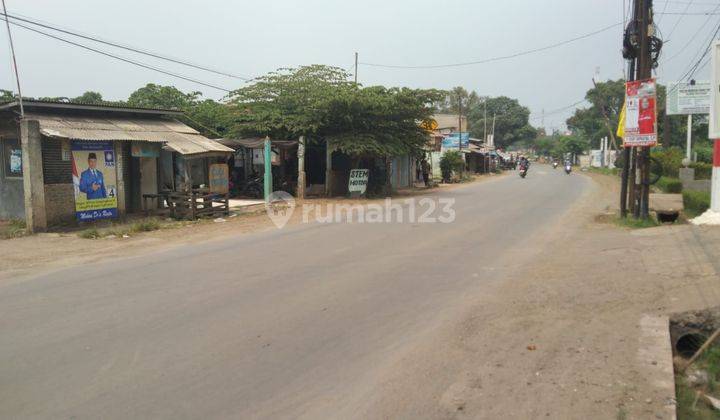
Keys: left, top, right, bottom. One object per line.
{"left": 0, "top": 173, "right": 508, "bottom": 282}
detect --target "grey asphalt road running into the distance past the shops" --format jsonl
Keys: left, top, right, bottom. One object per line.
{"left": 0, "top": 165, "right": 591, "bottom": 419}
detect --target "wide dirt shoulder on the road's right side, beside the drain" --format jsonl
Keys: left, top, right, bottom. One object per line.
{"left": 363, "top": 174, "right": 720, "bottom": 419}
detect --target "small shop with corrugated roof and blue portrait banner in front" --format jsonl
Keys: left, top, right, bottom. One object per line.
{"left": 0, "top": 101, "right": 233, "bottom": 231}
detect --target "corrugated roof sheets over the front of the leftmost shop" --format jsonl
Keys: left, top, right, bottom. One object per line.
{"left": 26, "top": 114, "right": 233, "bottom": 155}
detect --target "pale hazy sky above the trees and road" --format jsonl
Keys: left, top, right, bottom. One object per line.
{"left": 0, "top": 0, "right": 720, "bottom": 128}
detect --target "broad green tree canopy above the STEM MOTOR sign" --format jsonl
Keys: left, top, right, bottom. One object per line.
{"left": 230, "top": 65, "right": 444, "bottom": 156}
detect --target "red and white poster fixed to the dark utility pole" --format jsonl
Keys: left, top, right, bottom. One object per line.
{"left": 623, "top": 79, "right": 657, "bottom": 147}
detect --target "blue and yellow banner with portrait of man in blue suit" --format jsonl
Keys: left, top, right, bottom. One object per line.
{"left": 71, "top": 141, "right": 118, "bottom": 222}
